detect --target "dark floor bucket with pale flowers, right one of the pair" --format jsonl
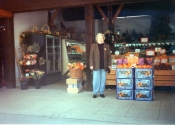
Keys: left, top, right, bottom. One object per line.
{"left": 29, "top": 69, "right": 44, "bottom": 89}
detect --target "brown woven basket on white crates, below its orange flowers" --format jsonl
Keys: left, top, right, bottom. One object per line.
{"left": 69, "top": 69, "right": 83, "bottom": 79}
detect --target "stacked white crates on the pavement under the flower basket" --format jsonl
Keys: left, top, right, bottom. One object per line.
{"left": 66, "top": 78, "right": 83, "bottom": 94}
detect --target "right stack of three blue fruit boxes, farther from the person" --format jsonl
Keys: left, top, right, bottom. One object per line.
{"left": 135, "top": 68, "right": 154, "bottom": 101}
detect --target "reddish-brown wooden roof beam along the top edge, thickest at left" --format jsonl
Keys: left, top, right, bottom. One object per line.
{"left": 0, "top": 0, "right": 160, "bottom": 13}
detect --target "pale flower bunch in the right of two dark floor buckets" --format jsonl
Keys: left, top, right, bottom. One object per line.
{"left": 29, "top": 69, "right": 45, "bottom": 80}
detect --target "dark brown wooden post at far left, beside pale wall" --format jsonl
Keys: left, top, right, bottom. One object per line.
{"left": 2, "top": 18, "right": 16, "bottom": 88}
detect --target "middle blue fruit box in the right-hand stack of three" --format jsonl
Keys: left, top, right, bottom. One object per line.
{"left": 135, "top": 79, "right": 154, "bottom": 90}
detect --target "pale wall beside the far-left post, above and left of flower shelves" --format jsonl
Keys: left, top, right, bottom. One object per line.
{"left": 14, "top": 11, "right": 48, "bottom": 86}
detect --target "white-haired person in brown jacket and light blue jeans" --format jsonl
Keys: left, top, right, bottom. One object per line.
{"left": 89, "top": 33, "right": 111, "bottom": 98}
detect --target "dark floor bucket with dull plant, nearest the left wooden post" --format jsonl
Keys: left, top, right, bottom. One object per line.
{"left": 19, "top": 75, "right": 29, "bottom": 90}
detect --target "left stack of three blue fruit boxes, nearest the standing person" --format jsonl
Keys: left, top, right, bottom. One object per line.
{"left": 116, "top": 68, "right": 134, "bottom": 100}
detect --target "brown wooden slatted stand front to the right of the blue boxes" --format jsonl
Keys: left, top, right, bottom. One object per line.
{"left": 154, "top": 70, "right": 175, "bottom": 86}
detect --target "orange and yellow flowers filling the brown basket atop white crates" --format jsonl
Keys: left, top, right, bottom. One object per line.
{"left": 67, "top": 62, "right": 86, "bottom": 70}
